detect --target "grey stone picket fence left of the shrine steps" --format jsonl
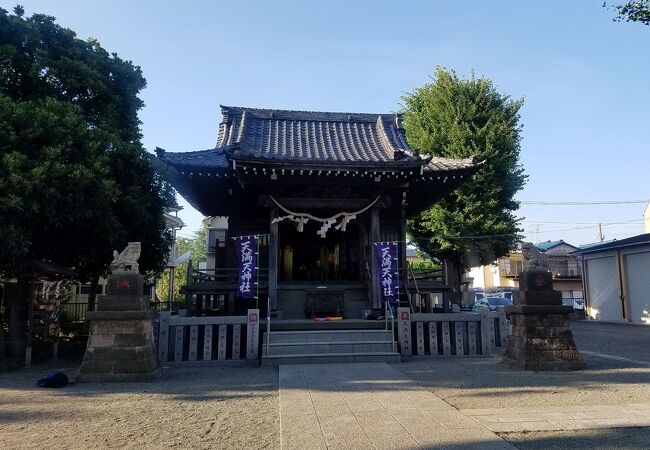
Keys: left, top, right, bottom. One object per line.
{"left": 157, "top": 309, "right": 260, "bottom": 363}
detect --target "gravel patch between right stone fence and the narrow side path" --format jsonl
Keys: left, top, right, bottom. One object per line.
{"left": 394, "top": 357, "right": 650, "bottom": 409}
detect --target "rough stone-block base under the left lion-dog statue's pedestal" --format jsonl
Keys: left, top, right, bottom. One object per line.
{"left": 76, "top": 311, "right": 160, "bottom": 382}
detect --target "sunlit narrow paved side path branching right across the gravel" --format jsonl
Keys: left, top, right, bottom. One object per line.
{"left": 461, "top": 403, "right": 650, "bottom": 433}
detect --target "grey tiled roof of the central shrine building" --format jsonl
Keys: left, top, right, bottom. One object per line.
{"left": 156, "top": 106, "right": 481, "bottom": 175}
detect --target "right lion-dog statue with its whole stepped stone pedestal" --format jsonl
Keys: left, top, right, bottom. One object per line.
{"left": 503, "top": 242, "right": 586, "bottom": 371}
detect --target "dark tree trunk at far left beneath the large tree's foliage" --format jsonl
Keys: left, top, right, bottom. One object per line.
{"left": 7, "top": 275, "right": 31, "bottom": 367}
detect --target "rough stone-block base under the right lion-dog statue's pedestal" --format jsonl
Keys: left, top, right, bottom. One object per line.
{"left": 503, "top": 306, "right": 586, "bottom": 371}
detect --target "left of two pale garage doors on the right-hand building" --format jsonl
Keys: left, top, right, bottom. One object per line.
{"left": 586, "top": 256, "right": 623, "bottom": 320}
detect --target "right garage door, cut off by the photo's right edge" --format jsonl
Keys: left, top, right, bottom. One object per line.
{"left": 624, "top": 252, "right": 650, "bottom": 323}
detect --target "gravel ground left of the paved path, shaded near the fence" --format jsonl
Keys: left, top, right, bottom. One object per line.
{"left": 0, "top": 366, "right": 280, "bottom": 449}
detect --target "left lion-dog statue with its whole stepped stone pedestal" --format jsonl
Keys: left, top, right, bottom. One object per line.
{"left": 76, "top": 242, "right": 160, "bottom": 382}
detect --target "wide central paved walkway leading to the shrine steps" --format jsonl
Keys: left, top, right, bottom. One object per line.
{"left": 279, "top": 363, "right": 515, "bottom": 449}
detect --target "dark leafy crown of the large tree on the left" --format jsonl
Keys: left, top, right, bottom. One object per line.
{"left": 0, "top": 7, "right": 173, "bottom": 362}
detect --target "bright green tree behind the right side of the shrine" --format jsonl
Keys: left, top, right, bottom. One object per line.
{"left": 403, "top": 68, "right": 526, "bottom": 306}
